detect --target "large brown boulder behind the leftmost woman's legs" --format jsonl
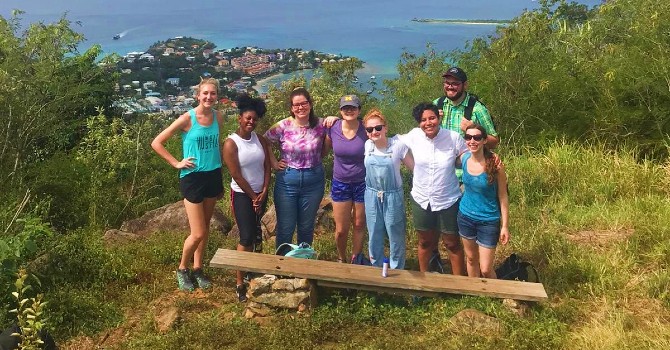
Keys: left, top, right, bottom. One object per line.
{"left": 121, "top": 201, "right": 231, "bottom": 236}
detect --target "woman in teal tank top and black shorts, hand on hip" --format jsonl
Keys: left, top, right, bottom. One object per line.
{"left": 151, "top": 78, "right": 223, "bottom": 291}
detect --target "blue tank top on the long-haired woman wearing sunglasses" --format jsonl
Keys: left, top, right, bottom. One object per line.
{"left": 458, "top": 152, "right": 500, "bottom": 222}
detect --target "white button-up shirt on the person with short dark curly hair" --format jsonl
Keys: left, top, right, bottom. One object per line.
{"left": 398, "top": 128, "right": 467, "bottom": 211}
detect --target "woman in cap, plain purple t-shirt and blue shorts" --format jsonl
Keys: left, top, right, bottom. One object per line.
{"left": 326, "top": 95, "right": 367, "bottom": 263}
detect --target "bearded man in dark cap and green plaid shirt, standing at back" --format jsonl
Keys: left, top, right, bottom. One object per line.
{"left": 433, "top": 67, "right": 500, "bottom": 148}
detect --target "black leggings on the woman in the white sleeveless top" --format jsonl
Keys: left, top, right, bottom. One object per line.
{"left": 230, "top": 191, "right": 268, "bottom": 247}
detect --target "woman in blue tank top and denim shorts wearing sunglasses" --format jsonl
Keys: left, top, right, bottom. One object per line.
{"left": 458, "top": 124, "right": 510, "bottom": 278}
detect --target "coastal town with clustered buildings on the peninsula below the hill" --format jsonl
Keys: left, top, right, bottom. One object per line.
{"left": 116, "top": 37, "right": 352, "bottom": 114}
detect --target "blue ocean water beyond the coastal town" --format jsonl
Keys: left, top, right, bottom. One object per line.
{"left": 0, "top": 0, "right": 600, "bottom": 90}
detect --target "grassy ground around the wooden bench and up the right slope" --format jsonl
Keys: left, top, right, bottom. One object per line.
{"left": 28, "top": 142, "right": 670, "bottom": 349}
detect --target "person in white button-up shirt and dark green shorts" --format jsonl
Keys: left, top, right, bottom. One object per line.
{"left": 400, "top": 102, "right": 467, "bottom": 275}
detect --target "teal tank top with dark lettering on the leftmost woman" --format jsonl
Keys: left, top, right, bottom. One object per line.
{"left": 179, "top": 109, "right": 221, "bottom": 178}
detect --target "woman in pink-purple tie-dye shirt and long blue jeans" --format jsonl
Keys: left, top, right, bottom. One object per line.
{"left": 265, "top": 87, "right": 337, "bottom": 247}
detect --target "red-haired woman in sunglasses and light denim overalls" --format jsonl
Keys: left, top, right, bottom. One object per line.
{"left": 363, "top": 109, "right": 414, "bottom": 269}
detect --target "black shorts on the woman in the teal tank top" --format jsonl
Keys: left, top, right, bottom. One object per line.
{"left": 179, "top": 168, "right": 223, "bottom": 203}
